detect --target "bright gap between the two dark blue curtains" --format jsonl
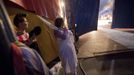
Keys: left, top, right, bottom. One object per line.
{"left": 98, "top": 0, "right": 115, "bottom": 29}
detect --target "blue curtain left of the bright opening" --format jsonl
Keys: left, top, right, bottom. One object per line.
{"left": 70, "top": 0, "right": 99, "bottom": 36}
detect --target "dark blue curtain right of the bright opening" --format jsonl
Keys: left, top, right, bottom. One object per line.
{"left": 112, "top": 0, "right": 134, "bottom": 28}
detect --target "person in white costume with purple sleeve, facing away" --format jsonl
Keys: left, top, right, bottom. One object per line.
{"left": 54, "top": 18, "right": 77, "bottom": 75}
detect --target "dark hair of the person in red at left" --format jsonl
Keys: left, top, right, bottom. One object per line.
{"left": 13, "top": 13, "right": 27, "bottom": 27}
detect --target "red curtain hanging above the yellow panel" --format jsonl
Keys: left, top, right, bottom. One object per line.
{"left": 9, "top": 0, "right": 60, "bottom": 20}
